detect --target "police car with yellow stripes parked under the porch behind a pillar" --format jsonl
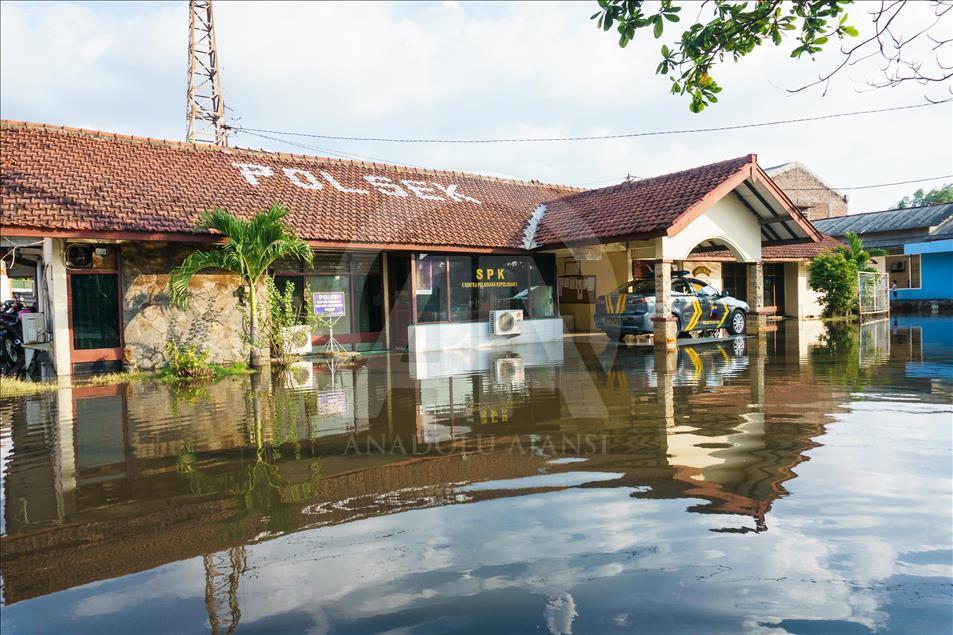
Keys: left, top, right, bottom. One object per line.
{"left": 595, "top": 271, "right": 748, "bottom": 340}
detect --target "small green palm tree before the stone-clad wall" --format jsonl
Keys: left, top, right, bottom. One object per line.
{"left": 169, "top": 204, "right": 312, "bottom": 366}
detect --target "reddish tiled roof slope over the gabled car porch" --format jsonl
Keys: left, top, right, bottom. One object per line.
{"left": 537, "top": 155, "right": 755, "bottom": 246}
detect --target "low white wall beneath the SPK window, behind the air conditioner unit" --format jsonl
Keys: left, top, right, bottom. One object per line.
{"left": 407, "top": 317, "right": 563, "bottom": 352}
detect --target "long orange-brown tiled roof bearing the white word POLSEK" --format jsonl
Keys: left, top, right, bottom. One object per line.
{"left": 0, "top": 121, "right": 579, "bottom": 249}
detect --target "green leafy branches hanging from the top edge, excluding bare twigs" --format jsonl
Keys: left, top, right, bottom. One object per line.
{"left": 592, "top": 0, "right": 857, "bottom": 112}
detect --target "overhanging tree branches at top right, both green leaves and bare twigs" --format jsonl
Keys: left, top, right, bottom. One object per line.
{"left": 592, "top": 0, "right": 953, "bottom": 112}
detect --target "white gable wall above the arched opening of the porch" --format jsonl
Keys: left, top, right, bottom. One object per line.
{"left": 656, "top": 194, "right": 761, "bottom": 262}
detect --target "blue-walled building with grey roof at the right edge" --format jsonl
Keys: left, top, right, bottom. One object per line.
{"left": 814, "top": 203, "right": 953, "bottom": 304}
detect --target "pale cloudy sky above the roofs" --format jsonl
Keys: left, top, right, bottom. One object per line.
{"left": 0, "top": 0, "right": 953, "bottom": 213}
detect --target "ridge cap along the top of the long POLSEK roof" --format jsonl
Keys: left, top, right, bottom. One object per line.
{"left": 0, "top": 119, "right": 587, "bottom": 194}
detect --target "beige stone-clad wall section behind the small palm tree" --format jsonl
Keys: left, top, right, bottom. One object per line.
{"left": 121, "top": 243, "right": 247, "bottom": 369}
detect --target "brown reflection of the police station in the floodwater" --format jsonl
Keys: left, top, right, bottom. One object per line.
{"left": 2, "top": 322, "right": 944, "bottom": 632}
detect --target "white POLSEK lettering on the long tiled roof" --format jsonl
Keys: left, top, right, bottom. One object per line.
{"left": 232, "top": 163, "right": 483, "bottom": 205}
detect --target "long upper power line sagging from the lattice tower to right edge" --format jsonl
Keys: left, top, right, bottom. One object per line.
{"left": 229, "top": 99, "right": 953, "bottom": 143}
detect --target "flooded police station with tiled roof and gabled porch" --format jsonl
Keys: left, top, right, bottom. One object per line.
{"left": 2, "top": 122, "right": 829, "bottom": 375}
